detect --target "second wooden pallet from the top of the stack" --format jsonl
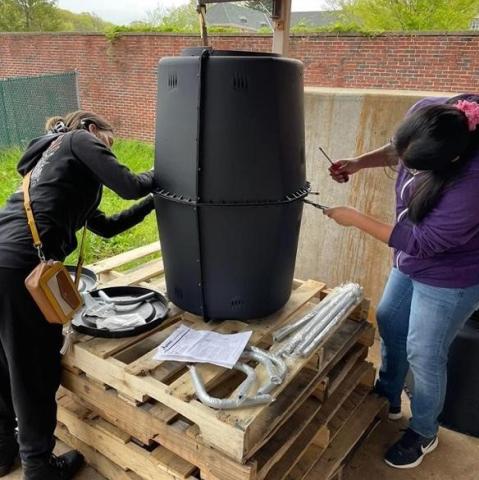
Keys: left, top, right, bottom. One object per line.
{"left": 62, "top": 321, "right": 374, "bottom": 480}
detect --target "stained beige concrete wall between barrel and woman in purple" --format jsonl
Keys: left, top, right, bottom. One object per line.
{"left": 296, "top": 88, "right": 452, "bottom": 314}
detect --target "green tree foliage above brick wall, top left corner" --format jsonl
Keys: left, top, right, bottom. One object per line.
{"left": 0, "top": 0, "right": 61, "bottom": 32}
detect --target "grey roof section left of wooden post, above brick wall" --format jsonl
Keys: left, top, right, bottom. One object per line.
{"left": 206, "top": 3, "right": 272, "bottom": 31}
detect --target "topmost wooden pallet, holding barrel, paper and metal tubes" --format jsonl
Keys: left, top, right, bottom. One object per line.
{"left": 64, "top": 247, "right": 371, "bottom": 463}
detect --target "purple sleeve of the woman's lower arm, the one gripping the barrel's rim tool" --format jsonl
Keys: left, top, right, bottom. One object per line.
{"left": 389, "top": 170, "right": 479, "bottom": 258}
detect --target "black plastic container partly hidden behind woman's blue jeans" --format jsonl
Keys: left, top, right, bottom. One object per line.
{"left": 439, "top": 312, "right": 479, "bottom": 437}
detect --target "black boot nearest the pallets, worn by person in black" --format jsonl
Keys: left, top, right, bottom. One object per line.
{"left": 23, "top": 450, "right": 85, "bottom": 480}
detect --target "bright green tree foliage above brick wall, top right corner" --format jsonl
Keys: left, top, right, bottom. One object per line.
{"left": 330, "top": 0, "right": 479, "bottom": 32}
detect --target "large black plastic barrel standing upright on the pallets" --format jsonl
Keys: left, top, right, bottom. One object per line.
{"left": 155, "top": 49, "right": 307, "bottom": 319}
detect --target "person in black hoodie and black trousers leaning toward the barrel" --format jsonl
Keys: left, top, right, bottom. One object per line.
{"left": 0, "top": 111, "right": 158, "bottom": 480}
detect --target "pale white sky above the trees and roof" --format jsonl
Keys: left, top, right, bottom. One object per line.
{"left": 57, "top": 0, "right": 327, "bottom": 24}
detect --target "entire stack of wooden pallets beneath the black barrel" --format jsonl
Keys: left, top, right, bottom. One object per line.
{"left": 56, "top": 244, "right": 385, "bottom": 480}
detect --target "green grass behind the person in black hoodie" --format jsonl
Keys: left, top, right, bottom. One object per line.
{"left": 0, "top": 140, "right": 158, "bottom": 264}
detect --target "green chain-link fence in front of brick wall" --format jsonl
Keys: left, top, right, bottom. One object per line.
{"left": 0, "top": 72, "right": 80, "bottom": 148}
